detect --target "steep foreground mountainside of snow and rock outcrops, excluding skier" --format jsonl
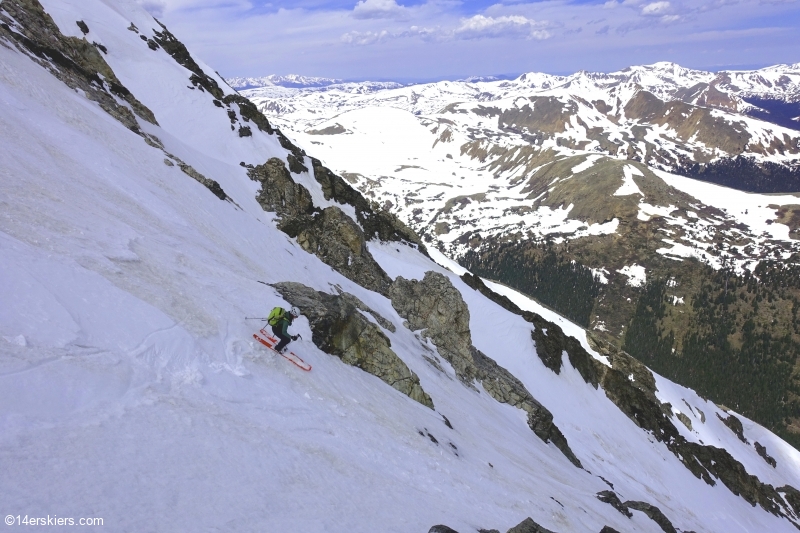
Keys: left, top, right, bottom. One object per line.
{"left": 0, "top": 0, "right": 800, "bottom": 532}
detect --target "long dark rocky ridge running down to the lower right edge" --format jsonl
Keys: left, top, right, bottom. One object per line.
{"left": 462, "top": 273, "right": 795, "bottom": 524}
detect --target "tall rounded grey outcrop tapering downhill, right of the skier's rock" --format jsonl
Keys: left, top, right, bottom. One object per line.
{"left": 389, "top": 271, "right": 581, "bottom": 468}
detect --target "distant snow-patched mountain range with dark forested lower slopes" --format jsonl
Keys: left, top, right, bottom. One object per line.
{"left": 239, "top": 63, "right": 800, "bottom": 445}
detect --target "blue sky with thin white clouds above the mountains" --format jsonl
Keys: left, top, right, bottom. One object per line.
{"left": 141, "top": 0, "right": 800, "bottom": 81}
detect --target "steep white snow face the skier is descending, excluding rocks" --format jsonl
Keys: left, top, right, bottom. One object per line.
{"left": 0, "top": 0, "right": 800, "bottom": 532}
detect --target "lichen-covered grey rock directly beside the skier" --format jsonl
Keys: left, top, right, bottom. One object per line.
{"left": 274, "top": 282, "right": 433, "bottom": 409}
